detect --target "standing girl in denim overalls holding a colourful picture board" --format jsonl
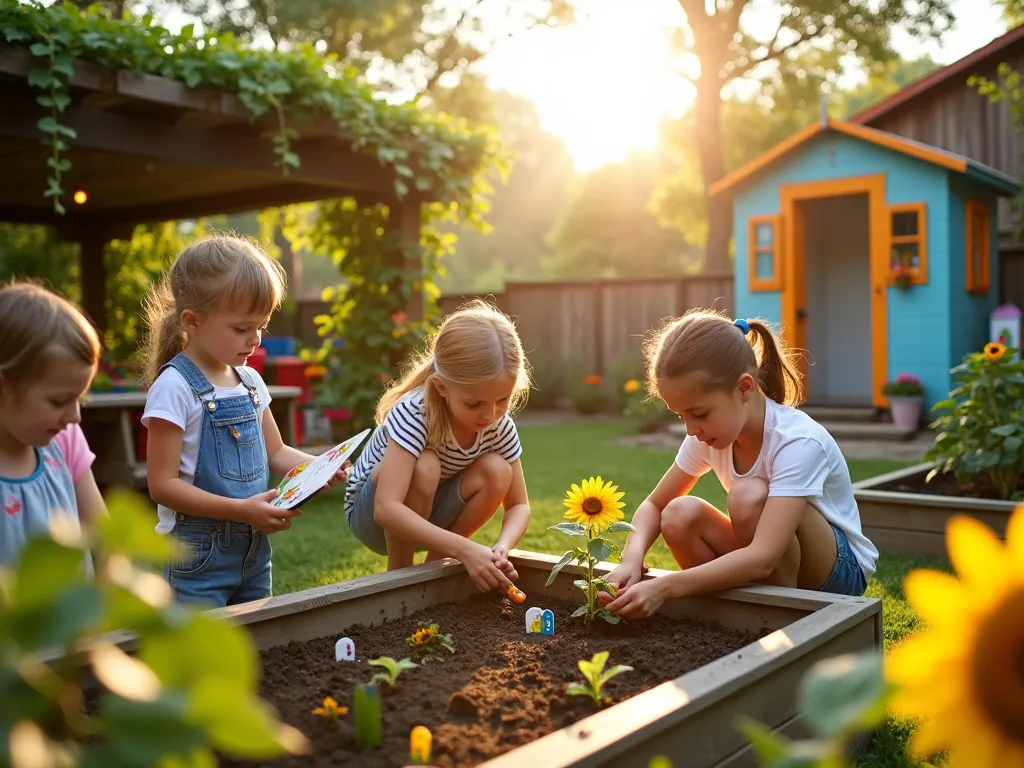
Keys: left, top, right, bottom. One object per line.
{"left": 142, "top": 238, "right": 347, "bottom": 607}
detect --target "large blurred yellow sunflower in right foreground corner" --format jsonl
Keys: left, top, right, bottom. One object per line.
{"left": 886, "top": 505, "right": 1024, "bottom": 768}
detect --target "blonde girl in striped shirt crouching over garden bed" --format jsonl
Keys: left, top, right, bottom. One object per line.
{"left": 345, "top": 301, "right": 529, "bottom": 592}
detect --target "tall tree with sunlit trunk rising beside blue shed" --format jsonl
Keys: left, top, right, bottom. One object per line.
{"left": 679, "top": 0, "right": 953, "bottom": 269}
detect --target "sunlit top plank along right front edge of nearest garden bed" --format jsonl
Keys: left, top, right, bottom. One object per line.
{"left": 479, "top": 602, "right": 882, "bottom": 768}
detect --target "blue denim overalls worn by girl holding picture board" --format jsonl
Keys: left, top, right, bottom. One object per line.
{"left": 161, "top": 354, "right": 270, "bottom": 605}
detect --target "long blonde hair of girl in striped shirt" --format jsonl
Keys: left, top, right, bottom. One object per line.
{"left": 376, "top": 299, "right": 530, "bottom": 449}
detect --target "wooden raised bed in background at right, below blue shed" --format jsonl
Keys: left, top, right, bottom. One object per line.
{"left": 853, "top": 462, "right": 1017, "bottom": 558}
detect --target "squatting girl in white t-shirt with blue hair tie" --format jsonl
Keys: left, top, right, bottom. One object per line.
{"left": 604, "top": 310, "right": 879, "bottom": 618}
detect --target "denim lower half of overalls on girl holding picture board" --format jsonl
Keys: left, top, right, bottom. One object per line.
{"left": 164, "top": 514, "right": 271, "bottom": 607}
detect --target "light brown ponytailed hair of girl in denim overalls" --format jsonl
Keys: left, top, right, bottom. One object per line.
{"left": 143, "top": 236, "right": 285, "bottom": 382}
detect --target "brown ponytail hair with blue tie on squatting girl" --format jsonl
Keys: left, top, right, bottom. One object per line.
{"left": 644, "top": 309, "right": 803, "bottom": 406}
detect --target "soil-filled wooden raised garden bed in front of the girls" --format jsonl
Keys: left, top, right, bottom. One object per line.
{"left": 207, "top": 552, "right": 882, "bottom": 768}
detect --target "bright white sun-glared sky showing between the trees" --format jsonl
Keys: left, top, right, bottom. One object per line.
{"left": 483, "top": 0, "right": 1006, "bottom": 172}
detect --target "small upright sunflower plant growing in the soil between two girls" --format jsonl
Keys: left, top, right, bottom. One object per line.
{"left": 546, "top": 477, "right": 634, "bottom": 624}
